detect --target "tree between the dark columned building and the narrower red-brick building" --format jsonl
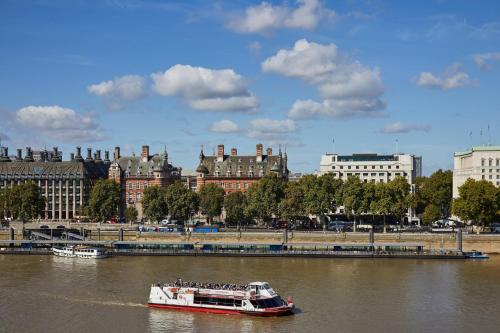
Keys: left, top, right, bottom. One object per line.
{"left": 88, "top": 179, "right": 120, "bottom": 221}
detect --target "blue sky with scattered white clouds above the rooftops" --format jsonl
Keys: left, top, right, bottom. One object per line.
{"left": 0, "top": 0, "right": 500, "bottom": 175}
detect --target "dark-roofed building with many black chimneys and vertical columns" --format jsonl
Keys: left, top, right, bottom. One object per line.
{"left": 0, "top": 147, "right": 111, "bottom": 220}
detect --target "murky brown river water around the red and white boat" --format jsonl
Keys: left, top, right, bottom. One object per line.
{"left": 0, "top": 255, "right": 500, "bottom": 332}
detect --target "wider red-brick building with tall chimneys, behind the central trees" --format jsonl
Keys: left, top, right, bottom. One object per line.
{"left": 196, "top": 144, "right": 289, "bottom": 194}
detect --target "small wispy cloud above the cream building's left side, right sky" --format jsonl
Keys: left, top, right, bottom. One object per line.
{"left": 416, "top": 63, "right": 473, "bottom": 90}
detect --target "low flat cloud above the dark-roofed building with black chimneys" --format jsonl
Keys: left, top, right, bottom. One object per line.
{"left": 15, "top": 105, "right": 104, "bottom": 142}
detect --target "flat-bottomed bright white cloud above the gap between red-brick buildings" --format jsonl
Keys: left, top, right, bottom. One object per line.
{"left": 151, "top": 65, "right": 258, "bottom": 111}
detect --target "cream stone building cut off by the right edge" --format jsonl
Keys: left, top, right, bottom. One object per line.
{"left": 453, "top": 146, "right": 500, "bottom": 198}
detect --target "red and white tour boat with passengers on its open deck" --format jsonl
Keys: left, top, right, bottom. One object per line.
{"left": 148, "top": 279, "right": 295, "bottom": 317}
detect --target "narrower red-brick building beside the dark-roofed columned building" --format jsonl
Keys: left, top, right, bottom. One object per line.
{"left": 109, "top": 146, "right": 181, "bottom": 218}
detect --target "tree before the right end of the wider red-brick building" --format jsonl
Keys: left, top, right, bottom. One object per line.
{"left": 247, "top": 174, "right": 285, "bottom": 222}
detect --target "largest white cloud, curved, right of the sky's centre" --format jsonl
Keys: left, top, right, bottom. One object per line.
{"left": 262, "top": 39, "right": 385, "bottom": 119}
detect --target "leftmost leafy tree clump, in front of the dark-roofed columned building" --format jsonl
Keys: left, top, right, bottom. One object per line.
{"left": 0, "top": 182, "right": 45, "bottom": 220}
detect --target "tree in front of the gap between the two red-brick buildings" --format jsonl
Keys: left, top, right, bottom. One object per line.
{"left": 165, "top": 182, "right": 199, "bottom": 220}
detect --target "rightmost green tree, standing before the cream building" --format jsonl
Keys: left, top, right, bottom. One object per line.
{"left": 453, "top": 178, "right": 500, "bottom": 226}
